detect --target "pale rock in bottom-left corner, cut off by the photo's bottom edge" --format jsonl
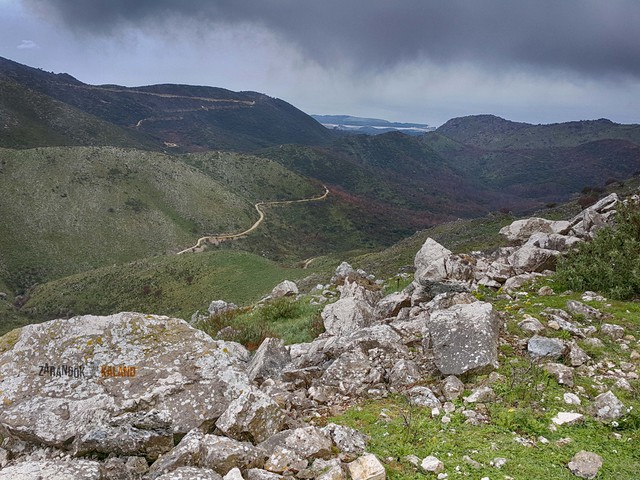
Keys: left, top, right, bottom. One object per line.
{"left": 0, "top": 458, "right": 102, "bottom": 480}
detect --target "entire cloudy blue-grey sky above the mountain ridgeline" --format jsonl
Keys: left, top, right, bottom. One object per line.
{"left": 0, "top": 0, "right": 640, "bottom": 126}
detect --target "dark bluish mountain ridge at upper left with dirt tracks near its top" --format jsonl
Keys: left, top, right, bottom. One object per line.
{"left": 0, "top": 57, "right": 333, "bottom": 152}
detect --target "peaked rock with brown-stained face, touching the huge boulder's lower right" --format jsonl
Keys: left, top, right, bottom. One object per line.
{"left": 216, "top": 388, "right": 286, "bottom": 442}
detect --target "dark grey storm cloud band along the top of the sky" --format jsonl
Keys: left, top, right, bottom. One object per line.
{"left": 24, "top": 0, "right": 640, "bottom": 78}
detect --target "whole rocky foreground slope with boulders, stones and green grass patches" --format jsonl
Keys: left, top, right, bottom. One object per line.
{"left": 0, "top": 195, "right": 640, "bottom": 480}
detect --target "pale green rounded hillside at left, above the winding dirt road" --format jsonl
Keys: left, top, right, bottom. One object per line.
{"left": 0, "top": 147, "right": 321, "bottom": 292}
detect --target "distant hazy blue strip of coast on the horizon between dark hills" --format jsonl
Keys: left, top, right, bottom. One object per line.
{"left": 311, "top": 115, "right": 435, "bottom": 135}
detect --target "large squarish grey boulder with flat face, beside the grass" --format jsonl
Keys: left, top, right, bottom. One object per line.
{"left": 425, "top": 302, "right": 501, "bottom": 375}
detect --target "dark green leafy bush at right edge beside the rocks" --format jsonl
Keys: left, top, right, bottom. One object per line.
{"left": 556, "top": 203, "right": 640, "bottom": 300}
